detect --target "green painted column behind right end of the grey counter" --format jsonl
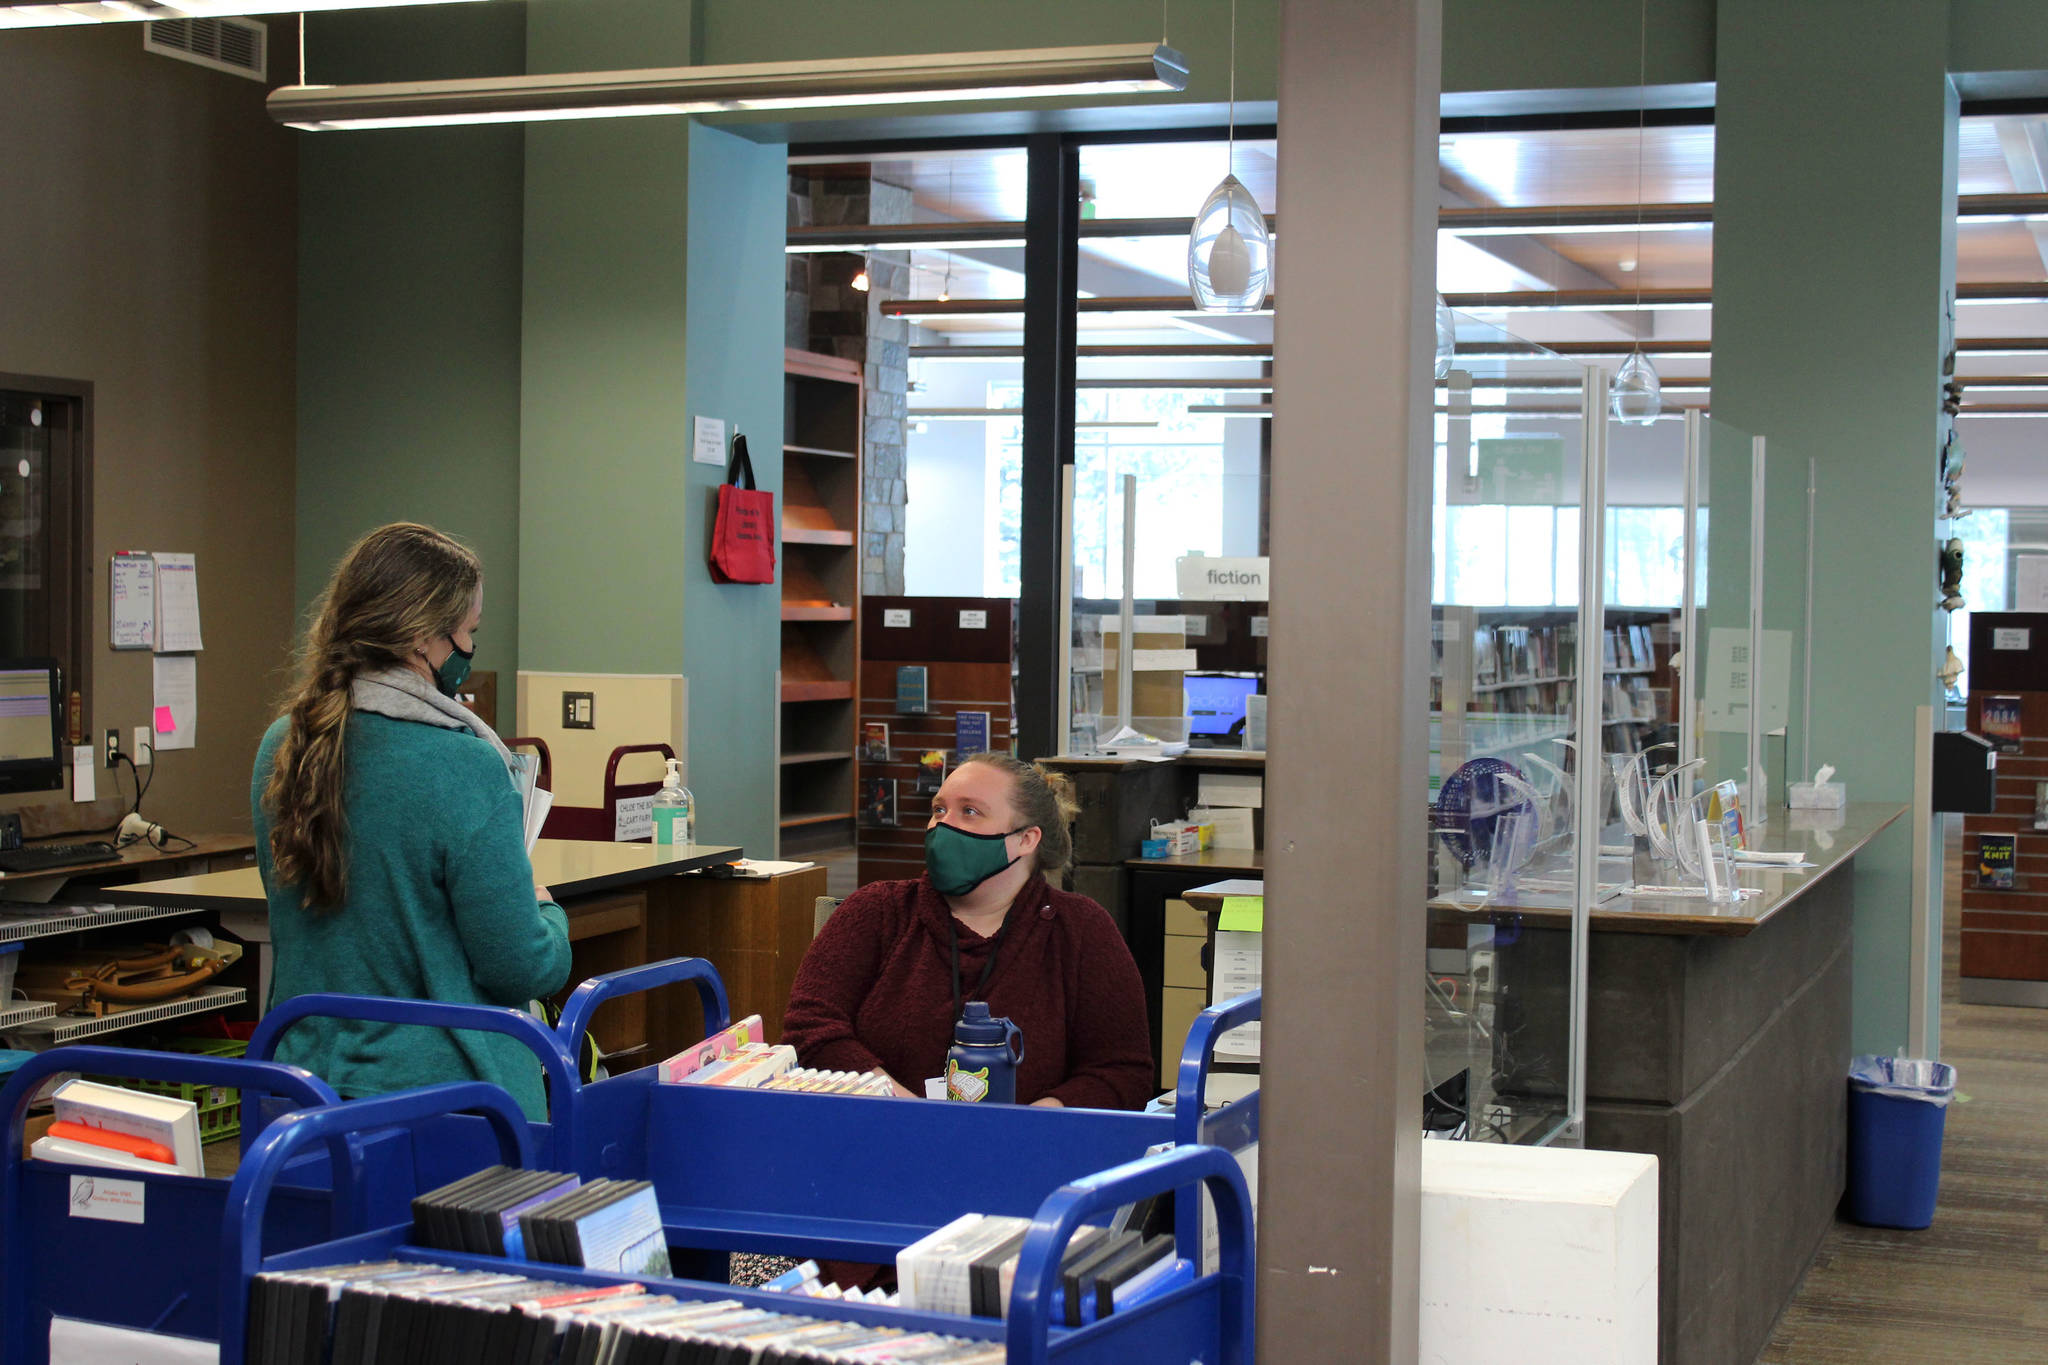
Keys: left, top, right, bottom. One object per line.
{"left": 1714, "top": 0, "right": 1956, "bottom": 1052}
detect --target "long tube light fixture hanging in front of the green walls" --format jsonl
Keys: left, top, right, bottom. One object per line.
{"left": 268, "top": 43, "right": 1188, "bottom": 131}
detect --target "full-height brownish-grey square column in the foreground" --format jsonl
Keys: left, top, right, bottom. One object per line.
{"left": 1257, "top": 0, "right": 1442, "bottom": 1361}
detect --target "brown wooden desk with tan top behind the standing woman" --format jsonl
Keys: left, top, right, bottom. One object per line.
{"left": 108, "top": 839, "right": 825, "bottom": 1064}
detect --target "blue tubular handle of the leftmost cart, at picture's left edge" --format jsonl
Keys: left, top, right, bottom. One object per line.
{"left": 0, "top": 1046, "right": 354, "bottom": 1355}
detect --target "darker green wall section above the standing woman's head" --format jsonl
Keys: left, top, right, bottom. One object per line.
{"left": 293, "top": 4, "right": 526, "bottom": 683}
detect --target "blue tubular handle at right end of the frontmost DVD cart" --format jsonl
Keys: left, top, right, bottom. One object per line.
{"left": 1008, "top": 1146, "right": 1251, "bottom": 1365}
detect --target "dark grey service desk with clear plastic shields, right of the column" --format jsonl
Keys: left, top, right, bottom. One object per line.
{"left": 1425, "top": 804, "right": 1905, "bottom": 1365}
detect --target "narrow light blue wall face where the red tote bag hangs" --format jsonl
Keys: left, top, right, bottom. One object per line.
{"left": 678, "top": 127, "right": 788, "bottom": 857}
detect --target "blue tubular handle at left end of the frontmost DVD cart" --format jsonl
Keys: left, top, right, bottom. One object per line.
{"left": 221, "top": 1081, "right": 532, "bottom": 1365}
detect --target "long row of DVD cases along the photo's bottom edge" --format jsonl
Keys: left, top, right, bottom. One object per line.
{"left": 246, "top": 1261, "right": 1006, "bottom": 1365}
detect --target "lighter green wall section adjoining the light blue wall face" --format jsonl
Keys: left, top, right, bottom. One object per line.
{"left": 518, "top": 0, "right": 696, "bottom": 673}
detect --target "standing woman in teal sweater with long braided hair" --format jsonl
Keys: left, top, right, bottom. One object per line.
{"left": 250, "top": 524, "right": 569, "bottom": 1119}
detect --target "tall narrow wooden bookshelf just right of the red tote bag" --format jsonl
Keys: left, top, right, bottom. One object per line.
{"left": 776, "top": 350, "right": 862, "bottom": 853}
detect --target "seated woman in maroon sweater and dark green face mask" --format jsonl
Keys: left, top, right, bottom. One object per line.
{"left": 782, "top": 753, "right": 1153, "bottom": 1109}
